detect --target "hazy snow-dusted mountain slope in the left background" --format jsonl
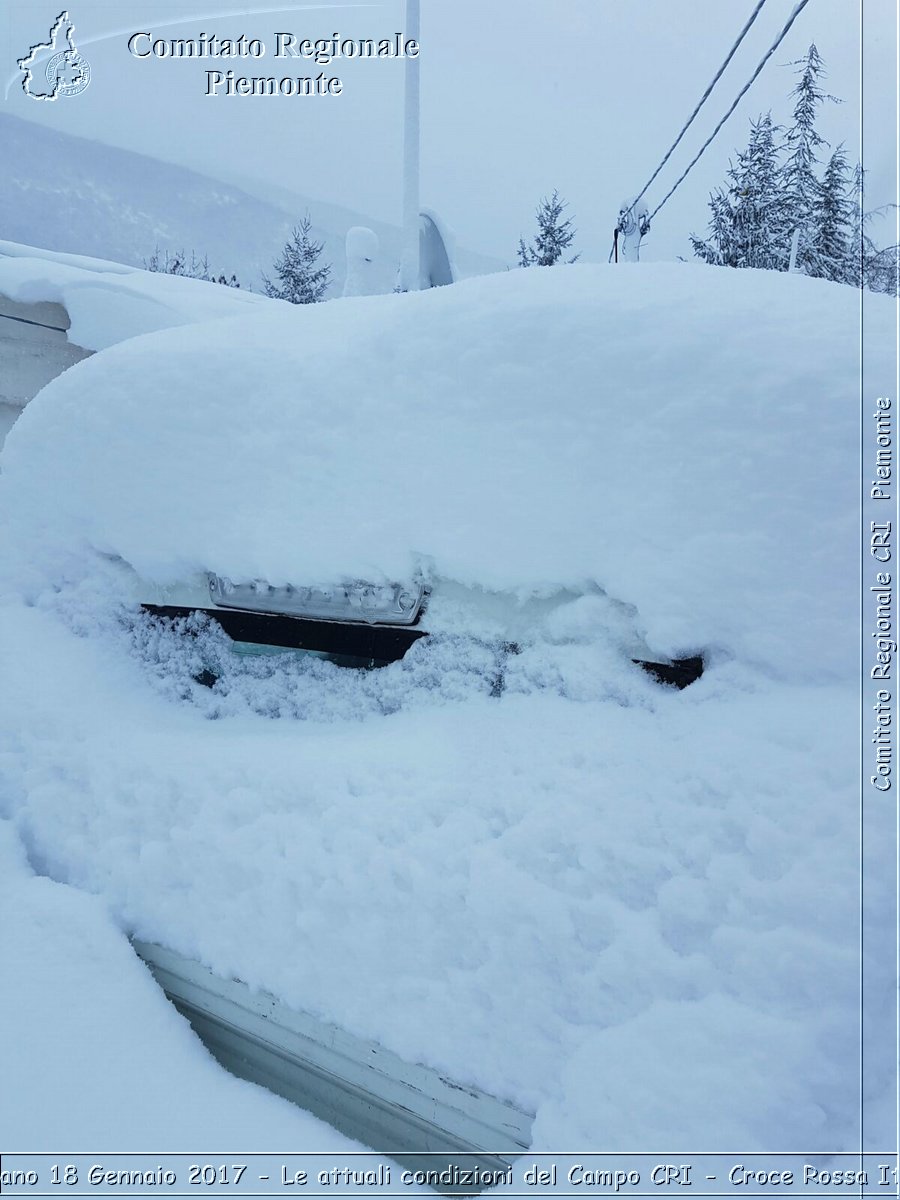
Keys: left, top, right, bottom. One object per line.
{"left": 0, "top": 114, "right": 502, "bottom": 296}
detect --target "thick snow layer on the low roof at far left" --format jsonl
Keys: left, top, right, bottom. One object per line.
{"left": 0, "top": 241, "right": 280, "bottom": 350}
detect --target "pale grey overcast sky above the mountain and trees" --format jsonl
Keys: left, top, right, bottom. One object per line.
{"left": 0, "top": 0, "right": 898, "bottom": 262}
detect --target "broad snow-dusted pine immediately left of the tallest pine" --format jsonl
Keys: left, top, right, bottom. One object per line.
{"left": 691, "top": 113, "right": 790, "bottom": 270}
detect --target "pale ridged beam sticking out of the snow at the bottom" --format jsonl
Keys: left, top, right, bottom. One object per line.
{"left": 133, "top": 941, "right": 533, "bottom": 1195}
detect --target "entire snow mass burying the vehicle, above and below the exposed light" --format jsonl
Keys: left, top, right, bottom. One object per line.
{"left": 0, "top": 266, "right": 894, "bottom": 1151}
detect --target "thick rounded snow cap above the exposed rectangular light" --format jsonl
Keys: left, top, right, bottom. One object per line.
{"left": 2, "top": 263, "right": 892, "bottom": 679}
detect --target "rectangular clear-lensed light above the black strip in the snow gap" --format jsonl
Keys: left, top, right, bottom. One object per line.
{"left": 209, "top": 575, "right": 425, "bottom": 625}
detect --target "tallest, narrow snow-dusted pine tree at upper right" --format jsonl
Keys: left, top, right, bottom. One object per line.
{"left": 782, "top": 42, "right": 840, "bottom": 275}
